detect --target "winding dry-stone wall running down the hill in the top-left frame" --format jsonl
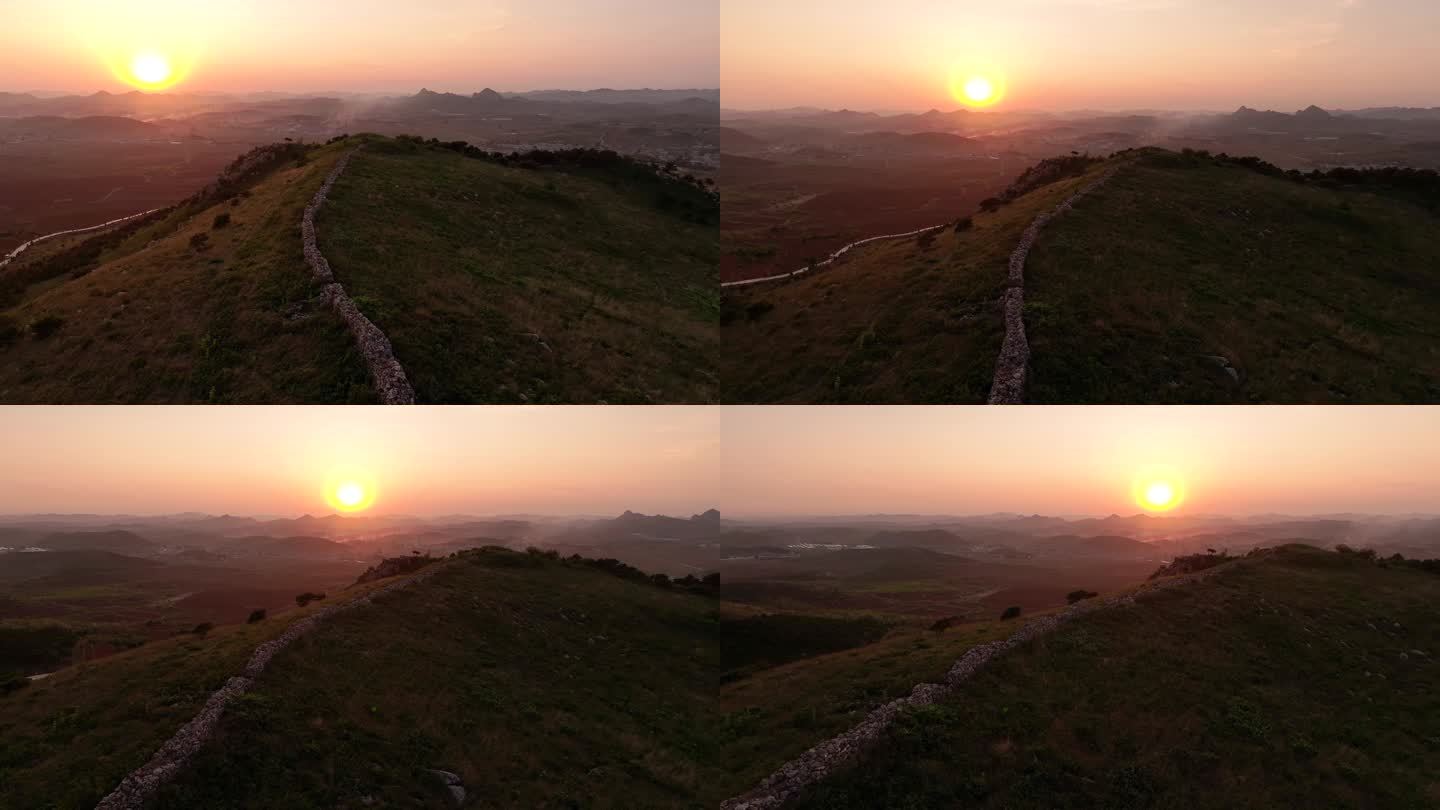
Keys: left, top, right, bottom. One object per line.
{"left": 300, "top": 147, "right": 415, "bottom": 405}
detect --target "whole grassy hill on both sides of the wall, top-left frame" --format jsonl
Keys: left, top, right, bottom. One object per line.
{"left": 0, "top": 135, "right": 719, "bottom": 404}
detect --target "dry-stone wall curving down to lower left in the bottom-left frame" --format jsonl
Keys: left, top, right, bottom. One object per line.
{"left": 95, "top": 553, "right": 445, "bottom": 810}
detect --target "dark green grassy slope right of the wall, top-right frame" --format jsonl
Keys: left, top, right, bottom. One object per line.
{"left": 1025, "top": 150, "right": 1440, "bottom": 404}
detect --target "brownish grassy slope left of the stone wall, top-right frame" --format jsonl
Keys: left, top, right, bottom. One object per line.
{"left": 720, "top": 169, "right": 1100, "bottom": 404}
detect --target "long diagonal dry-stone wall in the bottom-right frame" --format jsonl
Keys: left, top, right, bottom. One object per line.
{"left": 720, "top": 553, "right": 1228, "bottom": 810}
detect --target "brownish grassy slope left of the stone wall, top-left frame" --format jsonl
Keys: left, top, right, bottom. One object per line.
{"left": 0, "top": 144, "right": 374, "bottom": 404}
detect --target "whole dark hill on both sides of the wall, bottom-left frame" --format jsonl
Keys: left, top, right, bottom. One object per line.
{"left": 0, "top": 548, "right": 720, "bottom": 809}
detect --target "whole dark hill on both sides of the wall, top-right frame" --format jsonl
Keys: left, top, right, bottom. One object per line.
{"left": 721, "top": 147, "right": 1440, "bottom": 404}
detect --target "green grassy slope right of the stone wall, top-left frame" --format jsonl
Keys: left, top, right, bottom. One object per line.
{"left": 318, "top": 141, "right": 720, "bottom": 404}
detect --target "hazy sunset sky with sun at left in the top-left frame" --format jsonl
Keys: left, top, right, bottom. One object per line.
{"left": 0, "top": 0, "right": 720, "bottom": 92}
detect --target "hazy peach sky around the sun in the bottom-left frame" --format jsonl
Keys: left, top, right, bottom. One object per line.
{"left": 0, "top": 406, "right": 720, "bottom": 516}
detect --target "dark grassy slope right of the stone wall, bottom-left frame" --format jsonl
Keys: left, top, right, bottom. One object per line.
{"left": 157, "top": 552, "right": 720, "bottom": 809}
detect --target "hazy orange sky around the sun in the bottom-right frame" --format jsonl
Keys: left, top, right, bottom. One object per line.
{"left": 720, "top": 405, "right": 1440, "bottom": 516}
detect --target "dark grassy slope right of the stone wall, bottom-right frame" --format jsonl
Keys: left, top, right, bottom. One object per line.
{"left": 801, "top": 546, "right": 1440, "bottom": 810}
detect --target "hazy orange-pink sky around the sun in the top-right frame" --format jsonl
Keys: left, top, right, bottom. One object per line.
{"left": 720, "top": 0, "right": 1440, "bottom": 111}
